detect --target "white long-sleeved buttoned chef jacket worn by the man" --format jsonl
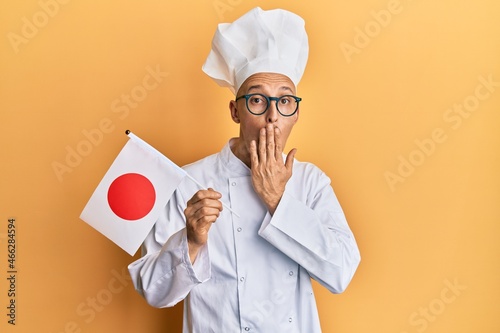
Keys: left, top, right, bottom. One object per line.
{"left": 129, "top": 141, "right": 360, "bottom": 333}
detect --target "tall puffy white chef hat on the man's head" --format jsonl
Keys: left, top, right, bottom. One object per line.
{"left": 202, "top": 7, "right": 309, "bottom": 94}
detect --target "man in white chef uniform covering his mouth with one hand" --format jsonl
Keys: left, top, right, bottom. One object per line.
{"left": 129, "top": 8, "right": 360, "bottom": 333}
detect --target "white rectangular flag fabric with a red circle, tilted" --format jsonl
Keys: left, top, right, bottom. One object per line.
{"left": 80, "top": 133, "right": 187, "bottom": 255}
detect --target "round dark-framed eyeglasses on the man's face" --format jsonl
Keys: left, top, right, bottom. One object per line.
{"left": 235, "top": 94, "right": 302, "bottom": 117}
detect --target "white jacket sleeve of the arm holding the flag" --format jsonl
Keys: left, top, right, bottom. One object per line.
{"left": 128, "top": 188, "right": 210, "bottom": 307}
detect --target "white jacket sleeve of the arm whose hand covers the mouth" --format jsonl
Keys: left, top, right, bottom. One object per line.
{"left": 259, "top": 167, "right": 361, "bottom": 293}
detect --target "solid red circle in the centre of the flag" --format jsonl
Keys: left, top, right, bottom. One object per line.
{"left": 108, "top": 173, "right": 156, "bottom": 221}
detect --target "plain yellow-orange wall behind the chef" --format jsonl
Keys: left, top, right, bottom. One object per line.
{"left": 0, "top": 0, "right": 500, "bottom": 333}
